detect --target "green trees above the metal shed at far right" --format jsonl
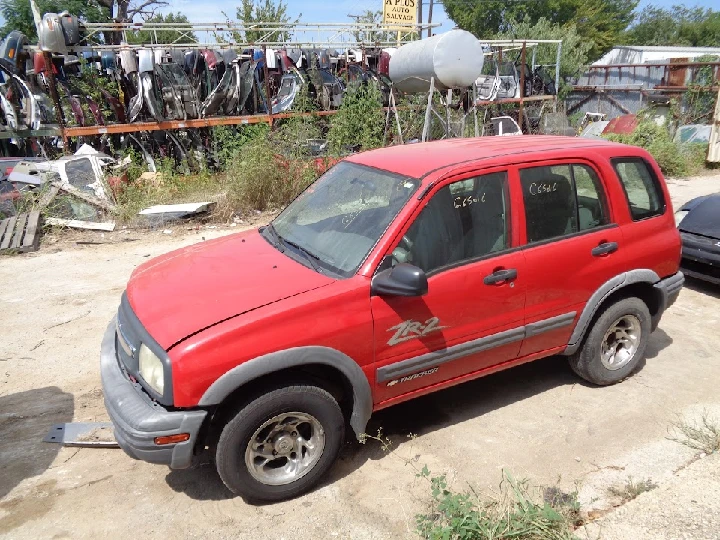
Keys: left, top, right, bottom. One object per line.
{"left": 623, "top": 5, "right": 720, "bottom": 47}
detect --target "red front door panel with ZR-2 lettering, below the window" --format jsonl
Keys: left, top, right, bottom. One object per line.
{"left": 371, "top": 251, "right": 527, "bottom": 401}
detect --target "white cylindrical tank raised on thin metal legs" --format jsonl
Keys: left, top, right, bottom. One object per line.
{"left": 390, "top": 30, "right": 484, "bottom": 94}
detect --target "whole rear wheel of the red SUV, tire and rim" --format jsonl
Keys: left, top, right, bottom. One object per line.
{"left": 569, "top": 297, "right": 651, "bottom": 386}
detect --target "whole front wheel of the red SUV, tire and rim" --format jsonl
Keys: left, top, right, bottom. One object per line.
{"left": 215, "top": 384, "right": 345, "bottom": 502}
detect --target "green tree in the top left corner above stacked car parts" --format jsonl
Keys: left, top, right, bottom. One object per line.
{"left": 0, "top": 0, "right": 110, "bottom": 42}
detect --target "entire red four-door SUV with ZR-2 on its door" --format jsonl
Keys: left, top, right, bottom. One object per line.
{"left": 101, "top": 136, "right": 684, "bottom": 501}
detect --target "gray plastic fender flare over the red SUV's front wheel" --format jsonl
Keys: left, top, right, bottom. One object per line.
{"left": 198, "top": 347, "right": 373, "bottom": 437}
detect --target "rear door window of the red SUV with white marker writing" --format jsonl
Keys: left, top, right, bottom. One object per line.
{"left": 520, "top": 164, "right": 608, "bottom": 243}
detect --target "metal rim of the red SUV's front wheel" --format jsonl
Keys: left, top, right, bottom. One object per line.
{"left": 245, "top": 412, "right": 325, "bottom": 486}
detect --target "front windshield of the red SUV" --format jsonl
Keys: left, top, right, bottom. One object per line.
{"left": 264, "top": 161, "right": 420, "bottom": 277}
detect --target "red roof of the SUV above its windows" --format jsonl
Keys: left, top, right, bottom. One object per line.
{"left": 346, "top": 135, "right": 629, "bottom": 178}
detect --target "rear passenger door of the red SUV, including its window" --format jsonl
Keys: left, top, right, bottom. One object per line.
{"left": 517, "top": 160, "right": 625, "bottom": 356}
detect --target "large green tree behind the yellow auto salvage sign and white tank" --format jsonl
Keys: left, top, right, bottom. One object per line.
{"left": 444, "top": 0, "right": 638, "bottom": 61}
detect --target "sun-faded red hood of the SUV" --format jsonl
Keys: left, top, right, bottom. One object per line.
{"left": 127, "top": 230, "right": 334, "bottom": 350}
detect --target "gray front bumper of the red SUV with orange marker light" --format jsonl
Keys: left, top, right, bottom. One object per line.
{"left": 100, "top": 318, "right": 207, "bottom": 469}
